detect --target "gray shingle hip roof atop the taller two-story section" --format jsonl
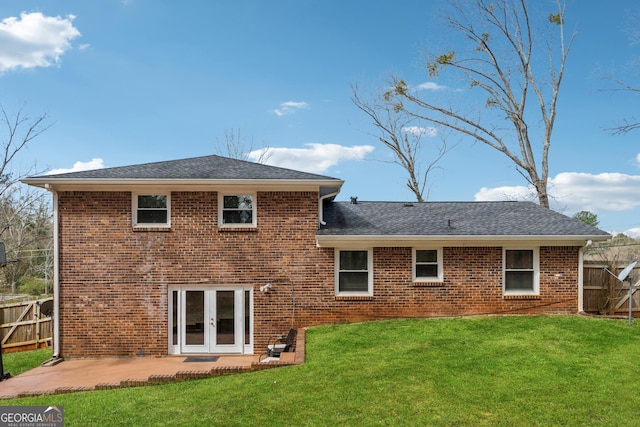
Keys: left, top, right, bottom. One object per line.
{"left": 25, "top": 155, "right": 341, "bottom": 182}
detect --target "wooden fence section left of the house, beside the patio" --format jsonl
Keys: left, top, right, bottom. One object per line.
{"left": 0, "top": 298, "right": 53, "bottom": 353}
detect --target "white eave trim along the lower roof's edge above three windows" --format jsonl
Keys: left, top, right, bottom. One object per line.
{"left": 316, "top": 235, "right": 609, "bottom": 248}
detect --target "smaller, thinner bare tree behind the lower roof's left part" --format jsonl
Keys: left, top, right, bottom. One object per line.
{"left": 352, "top": 86, "right": 448, "bottom": 203}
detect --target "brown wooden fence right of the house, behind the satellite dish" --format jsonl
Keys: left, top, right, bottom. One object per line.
{"left": 583, "top": 264, "right": 640, "bottom": 317}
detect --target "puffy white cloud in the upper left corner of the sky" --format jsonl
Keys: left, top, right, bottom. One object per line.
{"left": 0, "top": 12, "right": 81, "bottom": 73}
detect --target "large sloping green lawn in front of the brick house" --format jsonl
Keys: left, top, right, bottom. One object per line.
{"left": 0, "top": 316, "right": 640, "bottom": 426}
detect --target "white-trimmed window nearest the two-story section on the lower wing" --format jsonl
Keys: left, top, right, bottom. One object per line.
{"left": 336, "top": 249, "right": 373, "bottom": 295}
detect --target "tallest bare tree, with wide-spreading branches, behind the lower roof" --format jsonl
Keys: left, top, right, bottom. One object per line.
{"left": 372, "top": 0, "right": 575, "bottom": 207}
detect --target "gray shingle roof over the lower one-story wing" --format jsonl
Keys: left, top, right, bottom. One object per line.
{"left": 317, "top": 202, "right": 608, "bottom": 237}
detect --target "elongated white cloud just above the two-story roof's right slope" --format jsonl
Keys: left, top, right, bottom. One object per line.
{"left": 249, "top": 143, "right": 374, "bottom": 173}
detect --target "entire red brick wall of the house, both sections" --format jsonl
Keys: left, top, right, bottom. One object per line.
{"left": 58, "top": 192, "right": 578, "bottom": 358}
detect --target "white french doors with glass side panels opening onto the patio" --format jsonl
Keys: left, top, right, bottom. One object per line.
{"left": 169, "top": 287, "right": 253, "bottom": 354}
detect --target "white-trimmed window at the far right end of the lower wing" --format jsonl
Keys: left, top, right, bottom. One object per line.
{"left": 503, "top": 248, "right": 540, "bottom": 295}
